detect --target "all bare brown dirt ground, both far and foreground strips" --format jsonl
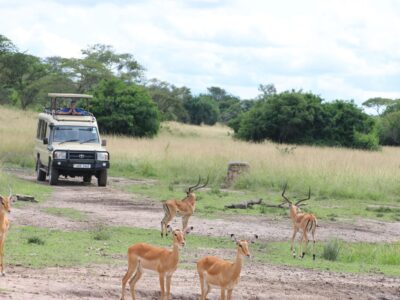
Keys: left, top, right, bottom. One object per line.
{"left": 0, "top": 174, "right": 400, "bottom": 299}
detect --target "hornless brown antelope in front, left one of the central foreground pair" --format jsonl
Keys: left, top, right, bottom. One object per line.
{"left": 121, "top": 226, "right": 190, "bottom": 300}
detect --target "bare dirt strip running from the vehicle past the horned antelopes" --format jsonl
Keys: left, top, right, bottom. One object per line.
{"left": 9, "top": 174, "right": 400, "bottom": 242}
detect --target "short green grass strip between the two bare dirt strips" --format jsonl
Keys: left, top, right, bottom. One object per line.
{"left": 5, "top": 227, "right": 400, "bottom": 277}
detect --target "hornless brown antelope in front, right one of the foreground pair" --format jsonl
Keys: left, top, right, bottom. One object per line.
{"left": 197, "top": 234, "right": 258, "bottom": 300}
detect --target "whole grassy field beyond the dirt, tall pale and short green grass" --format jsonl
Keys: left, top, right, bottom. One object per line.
{"left": 0, "top": 107, "right": 400, "bottom": 221}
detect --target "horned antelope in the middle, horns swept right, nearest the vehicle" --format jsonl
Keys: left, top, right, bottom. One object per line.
{"left": 161, "top": 176, "right": 209, "bottom": 237}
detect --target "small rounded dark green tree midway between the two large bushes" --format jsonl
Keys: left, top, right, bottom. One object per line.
{"left": 185, "top": 95, "right": 219, "bottom": 125}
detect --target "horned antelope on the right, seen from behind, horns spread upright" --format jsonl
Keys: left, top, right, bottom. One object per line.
{"left": 282, "top": 184, "right": 317, "bottom": 260}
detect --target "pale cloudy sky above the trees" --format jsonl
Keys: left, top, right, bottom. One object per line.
{"left": 0, "top": 0, "right": 400, "bottom": 104}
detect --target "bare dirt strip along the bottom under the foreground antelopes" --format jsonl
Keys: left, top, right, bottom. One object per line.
{"left": 0, "top": 262, "right": 400, "bottom": 300}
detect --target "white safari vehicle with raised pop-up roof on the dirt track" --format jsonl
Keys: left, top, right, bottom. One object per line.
{"left": 34, "top": 93, "right": 110, "bottom": 186}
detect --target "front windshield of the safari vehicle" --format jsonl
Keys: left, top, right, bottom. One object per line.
{"left": 52, "top": 126, "right": 99, "bottom": 144}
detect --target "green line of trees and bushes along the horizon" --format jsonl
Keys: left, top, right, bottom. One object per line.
{"left": 0, "top": 35, "right": 400, "bottom": 150}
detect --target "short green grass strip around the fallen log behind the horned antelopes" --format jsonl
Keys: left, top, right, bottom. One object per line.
{"left": 116, "top": 180, "right": 400, "bottom": 221}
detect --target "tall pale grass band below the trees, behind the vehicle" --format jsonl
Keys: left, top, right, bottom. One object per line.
{"left": 0, "top": 107, "right": 400, "bottom": 203}
